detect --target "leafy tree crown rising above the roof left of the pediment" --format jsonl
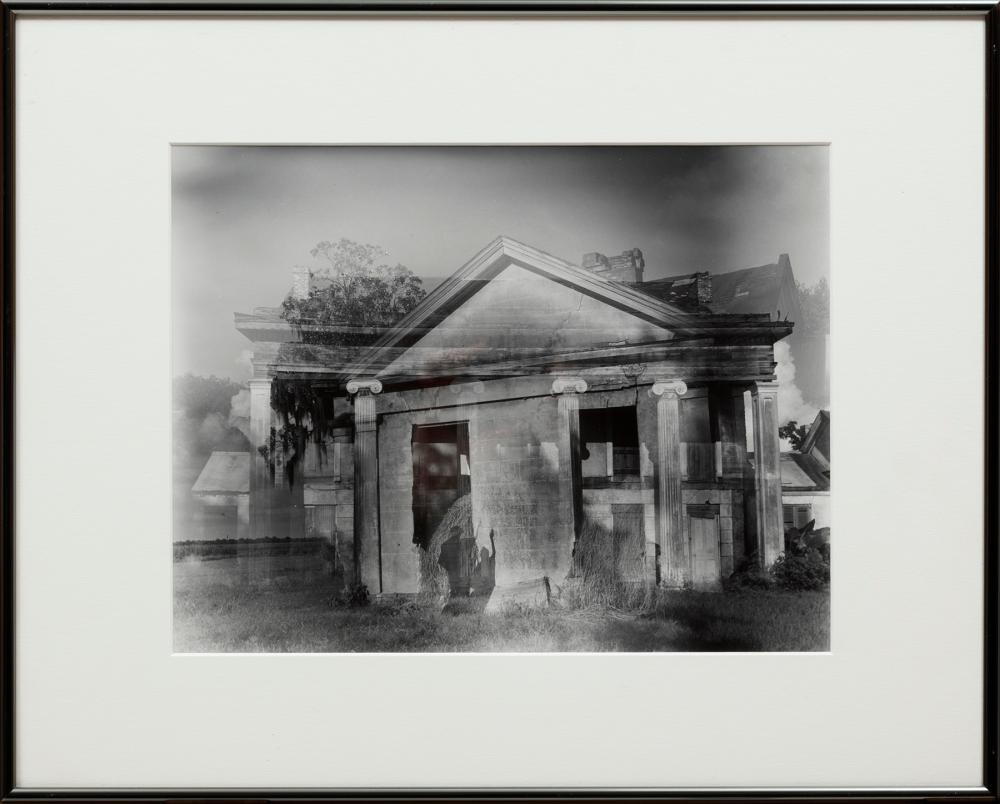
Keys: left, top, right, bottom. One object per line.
{"left": 281, "top": 239, "right": 426, "bottom": 346}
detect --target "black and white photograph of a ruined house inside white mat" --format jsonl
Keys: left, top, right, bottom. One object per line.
{"left": 171, "top": 145, "right": 833, "bottom": 653}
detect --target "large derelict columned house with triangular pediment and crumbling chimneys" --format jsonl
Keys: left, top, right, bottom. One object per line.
{"left": 236, "top": 237, "right": 793, "bottom": 597}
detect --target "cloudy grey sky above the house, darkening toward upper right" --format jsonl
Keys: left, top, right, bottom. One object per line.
{"left": 171, "top": 145, "right": 829, "bottom": 381}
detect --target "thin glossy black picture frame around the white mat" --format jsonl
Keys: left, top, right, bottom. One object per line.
{"left": 0, "top": 0, "right": 1000, "bottom": 802}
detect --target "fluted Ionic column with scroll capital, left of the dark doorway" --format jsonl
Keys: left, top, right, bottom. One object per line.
{"left": 347, "top": 380, "right": 382, "bottom": 595}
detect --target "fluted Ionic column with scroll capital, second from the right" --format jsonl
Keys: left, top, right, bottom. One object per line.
{"left": 650, "top": 380, "right": 690, "bottom": 587}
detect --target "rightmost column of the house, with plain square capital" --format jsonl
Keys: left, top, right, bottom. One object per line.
{"left": 750, "top": 382, "right": 785, "bottom": 567}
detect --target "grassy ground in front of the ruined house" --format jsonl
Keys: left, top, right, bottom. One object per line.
{"left": 174, "top": 559, "right": 830, "bottom": 653}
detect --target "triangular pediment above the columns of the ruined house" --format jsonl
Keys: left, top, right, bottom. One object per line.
{"left": 366, "top": 238, "right": 685, "bottom": 378}
